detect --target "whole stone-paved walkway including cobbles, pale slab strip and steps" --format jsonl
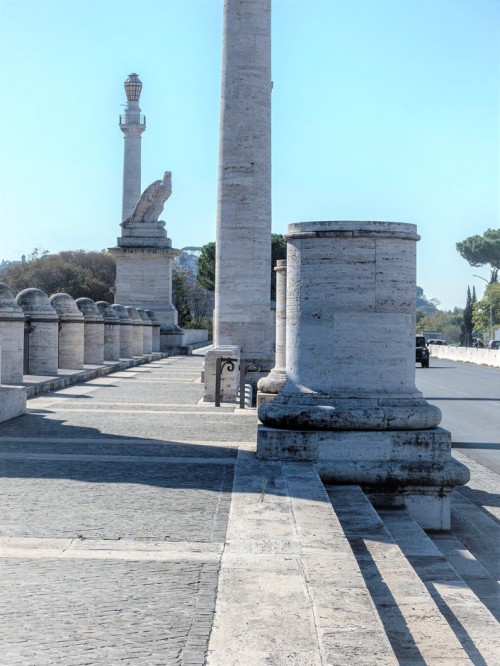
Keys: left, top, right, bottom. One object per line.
{"left": 0, "top": 355, "right": 500, "bottom": 666}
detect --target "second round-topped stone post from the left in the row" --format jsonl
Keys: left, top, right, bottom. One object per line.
{"left": 16, "top": 288, "right": 59, "bottom": 375}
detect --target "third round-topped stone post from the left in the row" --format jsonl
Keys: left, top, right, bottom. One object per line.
{"left": 49, "top": 294, "right": 85, "bottom": 369}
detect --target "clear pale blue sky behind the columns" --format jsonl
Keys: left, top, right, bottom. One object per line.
{"left": 0, "top": 0, "right": 500, "bottom": 308}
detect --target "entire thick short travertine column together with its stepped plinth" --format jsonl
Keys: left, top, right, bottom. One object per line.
{"left": 257, "top": 222, "right": 468, "bottom": 529}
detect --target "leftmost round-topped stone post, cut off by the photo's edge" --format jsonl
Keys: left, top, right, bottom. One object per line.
{"left": 0, "top": 282, "right": 24, "bottom": 384}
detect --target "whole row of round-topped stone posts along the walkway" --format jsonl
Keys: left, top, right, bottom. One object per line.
{"left": 0, "top": 283, "right": 160, "bottom": 384}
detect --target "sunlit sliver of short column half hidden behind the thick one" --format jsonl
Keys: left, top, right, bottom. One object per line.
{"left": 257, "top": 259, "right": 286, "bottom": 408}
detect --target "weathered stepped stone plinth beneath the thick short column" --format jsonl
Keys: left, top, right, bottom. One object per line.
{"left": 257, "top": 425, "right": 469, "bottom": 530}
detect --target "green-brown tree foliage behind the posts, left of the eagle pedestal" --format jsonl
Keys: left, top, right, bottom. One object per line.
{"left": 1, "top": 248, "right": 116, "bottom": 302}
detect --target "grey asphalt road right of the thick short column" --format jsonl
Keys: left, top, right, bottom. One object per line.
{"left": 415, "top": 358, "right": 500, "bottom": 474}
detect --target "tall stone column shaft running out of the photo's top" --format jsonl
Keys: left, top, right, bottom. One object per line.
{"left": 214, "top": 0, "right": 272, "bottom": 369}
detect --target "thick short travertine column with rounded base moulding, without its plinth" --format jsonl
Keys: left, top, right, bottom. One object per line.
{"left": 259, "top": 222, "right": 441, "bottom": 430}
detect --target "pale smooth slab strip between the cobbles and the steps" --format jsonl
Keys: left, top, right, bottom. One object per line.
{"left": 207, "top": 460, "right": 397, "bottom": 666}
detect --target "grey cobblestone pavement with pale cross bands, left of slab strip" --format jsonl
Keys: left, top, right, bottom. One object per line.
{"left": 0, "top": 356, "right": 255, "bottom": 666}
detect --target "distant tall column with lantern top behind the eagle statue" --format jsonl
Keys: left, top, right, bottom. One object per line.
{"left": 120, "top": 74, "right": 146, "bottom": 221}
